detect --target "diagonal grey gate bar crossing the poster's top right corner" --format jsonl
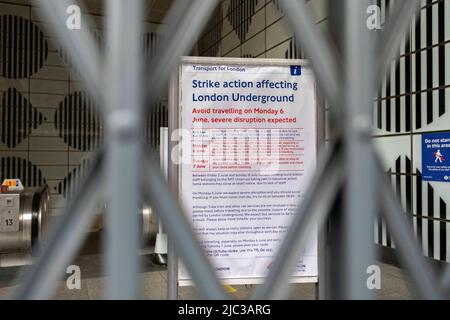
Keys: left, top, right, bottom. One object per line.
{"left": 279, "top": 0, "right": 342, "bottom": 113}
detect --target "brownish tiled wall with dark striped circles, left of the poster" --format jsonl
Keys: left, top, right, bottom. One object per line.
{"left": 0, "top": 0, "right": 167, "bottom": 214}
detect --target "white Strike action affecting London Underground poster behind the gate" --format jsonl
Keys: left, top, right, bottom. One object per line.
{"left": 179, "top": 58, "right": 317, "bottom": 284}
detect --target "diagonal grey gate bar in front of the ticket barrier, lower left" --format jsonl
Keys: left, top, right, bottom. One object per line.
{"left": 16, "top": 151, "right": 104, "bottom": 300}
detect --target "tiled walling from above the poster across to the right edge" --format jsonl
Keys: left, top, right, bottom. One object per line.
{"left": 197, "top": 0, "right": 450, "bottom": 261}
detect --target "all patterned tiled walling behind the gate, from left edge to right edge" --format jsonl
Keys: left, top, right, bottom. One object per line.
{"left": 0, "top": 0, "right": 450, "bottom": 261}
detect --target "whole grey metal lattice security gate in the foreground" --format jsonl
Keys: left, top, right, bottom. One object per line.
{"left": 12, "top": 0, "right": 450, "bottom": 299}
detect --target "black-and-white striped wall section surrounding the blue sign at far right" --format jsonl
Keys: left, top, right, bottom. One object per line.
{"left": 374, "top": 0, "right": 450, "bottom": 261}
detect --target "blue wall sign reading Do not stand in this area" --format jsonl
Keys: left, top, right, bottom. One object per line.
{"left": 422, "top": 132, "right": 450, "bottom": 182}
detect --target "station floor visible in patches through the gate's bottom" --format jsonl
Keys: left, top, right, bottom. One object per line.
{"left": 0, "top": 255, "right": 414, "bottom": 300}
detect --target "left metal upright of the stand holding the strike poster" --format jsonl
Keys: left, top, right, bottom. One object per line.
{"left": 167, "top": 70, "right": 179, "bottom": 300}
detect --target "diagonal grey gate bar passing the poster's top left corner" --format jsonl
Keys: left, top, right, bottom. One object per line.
{"left": 146, "top": 0, "right": 219, "bottom": 105}
